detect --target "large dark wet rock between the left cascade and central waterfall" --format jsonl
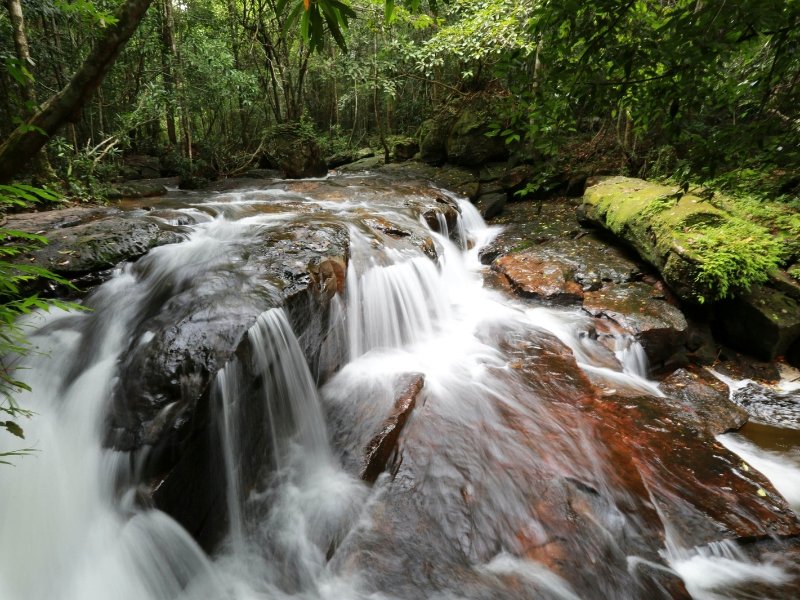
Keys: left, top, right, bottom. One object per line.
{"left": 108, "top": 221, "right": 349, "bottom": 549}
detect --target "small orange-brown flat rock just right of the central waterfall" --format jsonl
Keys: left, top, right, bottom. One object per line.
{"left": 492, "top": 252, "right": 583, "bottom": 304}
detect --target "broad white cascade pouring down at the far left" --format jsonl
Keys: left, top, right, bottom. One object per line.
{"left": 0, "top": 271, "right": 222, "bottom": 600}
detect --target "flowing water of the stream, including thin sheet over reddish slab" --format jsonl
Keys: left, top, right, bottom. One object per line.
{"left": 0, "top": 172, "right": 799, "bottom": 600}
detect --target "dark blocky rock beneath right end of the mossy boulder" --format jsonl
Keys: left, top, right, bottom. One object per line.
{"left": 714, "top": 285, "right": 800, "bottom": 360}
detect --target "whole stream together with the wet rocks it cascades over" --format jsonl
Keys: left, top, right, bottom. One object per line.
{"left": 0, "top": 175, "right": 800, "bottom": 600}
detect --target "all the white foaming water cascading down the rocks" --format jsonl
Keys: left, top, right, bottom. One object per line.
{"left": 0, "top": 183, "right": 788, "bottom": 600}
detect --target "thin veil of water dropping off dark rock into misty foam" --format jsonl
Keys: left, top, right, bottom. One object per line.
{"left": 211, "top": 309, "right": 366, "bottom": 598}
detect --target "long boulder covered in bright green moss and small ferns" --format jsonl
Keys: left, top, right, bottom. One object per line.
{"left": 579, "top": 177, "right": 785, "bottom": 303}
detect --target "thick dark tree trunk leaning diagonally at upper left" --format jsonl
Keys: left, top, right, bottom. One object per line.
{"left": 0, "top": 0, "right": 152, "bottom": 182}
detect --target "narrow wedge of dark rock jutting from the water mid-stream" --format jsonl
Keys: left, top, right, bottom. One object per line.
{"left": 361, "top": 373, "right": 425, "bottom": 483}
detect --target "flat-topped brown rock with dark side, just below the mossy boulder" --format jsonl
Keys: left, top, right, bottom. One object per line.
{"left": 583, "top": 282, "right": 688, "bottom": 367}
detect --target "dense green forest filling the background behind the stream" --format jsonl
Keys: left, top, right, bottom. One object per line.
{"left": 0, "top": 0, "right": 800, "bottom": 196}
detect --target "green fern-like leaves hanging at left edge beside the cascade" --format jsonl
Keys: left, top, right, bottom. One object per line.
{"left": 0, "top": 183, "right": 76, "bottom": 463}
